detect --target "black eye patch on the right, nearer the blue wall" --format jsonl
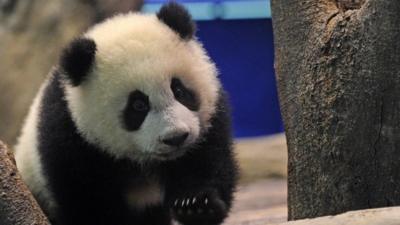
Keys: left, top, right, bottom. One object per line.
{"left": 171, "top": 78, "right": 200, "bottom": 111}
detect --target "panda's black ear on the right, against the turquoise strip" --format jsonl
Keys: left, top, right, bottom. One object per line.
{"left": 157, "top": 2, "right": 196, "bottom": 40}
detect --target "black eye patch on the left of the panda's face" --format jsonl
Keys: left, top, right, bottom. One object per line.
{"left": 122, "top": 91, "right": 150, "bottom": 131}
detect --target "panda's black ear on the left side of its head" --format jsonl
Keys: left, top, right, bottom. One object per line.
{"left": 60, "top": 38, "right": 96, "bottom": 86}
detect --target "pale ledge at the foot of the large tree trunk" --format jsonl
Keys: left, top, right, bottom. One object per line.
{"left": 275, "top": 207, "right": 400, "bottom": 225}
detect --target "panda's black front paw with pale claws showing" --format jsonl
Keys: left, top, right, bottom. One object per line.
{"left": 171, "top": 190, "right": 228, "bottom": 225}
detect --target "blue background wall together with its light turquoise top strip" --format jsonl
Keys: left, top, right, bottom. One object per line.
{"left": 144, "top": 0, "right": 283, "bottom": 137}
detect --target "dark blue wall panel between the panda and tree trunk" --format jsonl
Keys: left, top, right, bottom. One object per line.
{"left": 197, "top": 19, "right": 283, "bottom": 137}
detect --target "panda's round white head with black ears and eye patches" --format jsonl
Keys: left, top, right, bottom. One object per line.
{"left": 60, "top": 3, "right": 220, "bottom": 162}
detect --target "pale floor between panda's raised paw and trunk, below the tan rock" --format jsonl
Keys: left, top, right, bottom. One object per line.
{"left": 224, "top": 179, "right": 287, "bottom": 225}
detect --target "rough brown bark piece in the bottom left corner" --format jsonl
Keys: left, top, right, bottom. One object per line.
{"left": 0, "top": 141, "right": 50, "bottom": 225}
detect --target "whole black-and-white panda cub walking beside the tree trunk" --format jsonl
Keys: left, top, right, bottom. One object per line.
{"left": 16, "top": 3, "right": 237, "bottom": 225}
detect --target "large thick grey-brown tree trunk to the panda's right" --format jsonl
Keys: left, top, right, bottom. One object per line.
{"left": 272, "top": 0, "right": 400, "bottom": 220}
